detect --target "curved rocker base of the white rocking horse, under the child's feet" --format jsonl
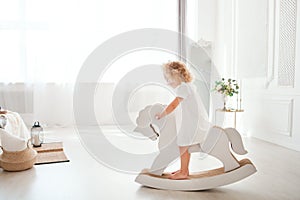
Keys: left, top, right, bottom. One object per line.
{"left": 135, "top": 159, "right": 256, "bottom": 191}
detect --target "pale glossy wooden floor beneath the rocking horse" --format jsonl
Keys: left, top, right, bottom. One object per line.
{"left": 0, "top": 128, "right": 300, "bottom": 200}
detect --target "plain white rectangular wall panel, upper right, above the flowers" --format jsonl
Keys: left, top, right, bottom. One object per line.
{"left": 233, "top": 0, "right": 268, "bottom": 78}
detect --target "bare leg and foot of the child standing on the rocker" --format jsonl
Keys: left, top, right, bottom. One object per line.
{"left": 169, "top": 146, "right": 191, "bottom": 180}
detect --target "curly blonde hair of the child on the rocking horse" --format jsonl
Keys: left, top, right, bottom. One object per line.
{"left": 163, "top": 61, "right": 193, "bottom": 83}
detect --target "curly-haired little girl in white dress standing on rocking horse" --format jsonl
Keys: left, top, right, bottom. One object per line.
{"left": 156, "top": 61, "right": 209, "bottom": 180}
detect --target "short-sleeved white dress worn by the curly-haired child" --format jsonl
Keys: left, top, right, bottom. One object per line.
{"left": 175, "top": 82, "right": 210, "bottom": 146}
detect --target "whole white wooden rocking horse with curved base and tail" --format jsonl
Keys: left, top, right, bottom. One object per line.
{"left": 134, "top": 104, "right": 256, "bottom": 191}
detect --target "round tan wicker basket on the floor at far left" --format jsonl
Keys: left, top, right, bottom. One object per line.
{"left": 0, "top": 141, "right": 37, "bottom": 172}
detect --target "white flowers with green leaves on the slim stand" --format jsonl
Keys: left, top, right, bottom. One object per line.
{"left": 213, "top": 78, "right": 239, "bottom": 97}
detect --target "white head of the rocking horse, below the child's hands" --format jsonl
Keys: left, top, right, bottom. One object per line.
{"left": 134, "top": 103, "right": 166, "bottom": 140}
